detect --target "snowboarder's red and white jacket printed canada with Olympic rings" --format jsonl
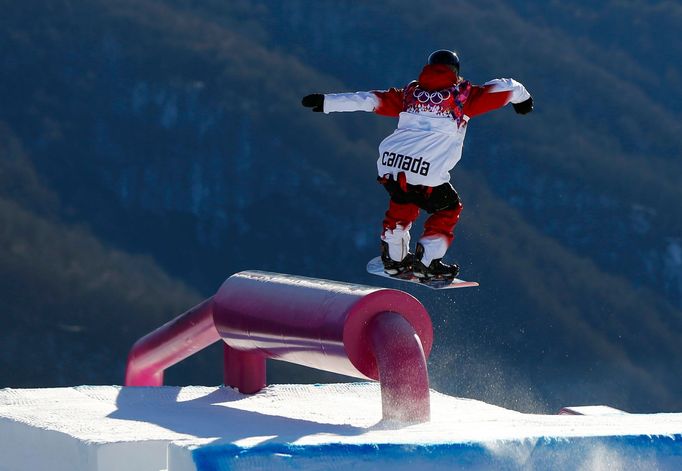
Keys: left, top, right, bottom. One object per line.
{"left": 324, "top": 66, "right": 530, "bottom": 187}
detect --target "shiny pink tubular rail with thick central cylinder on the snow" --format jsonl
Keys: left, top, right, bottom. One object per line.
{"left": 125, "top": 271, "right": 433, "bottom": 423}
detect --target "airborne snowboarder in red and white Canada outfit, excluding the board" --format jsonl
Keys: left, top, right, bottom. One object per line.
{"left": 302, "top": 50, "right": 533, "bottom": 281}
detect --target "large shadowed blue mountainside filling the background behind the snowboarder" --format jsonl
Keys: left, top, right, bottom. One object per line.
{"left": 0, "top": 0, "right": 682, "bottom": 411}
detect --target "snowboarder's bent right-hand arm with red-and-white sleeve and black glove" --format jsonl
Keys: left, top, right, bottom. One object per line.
{"left": 463, "top": 79, "right": 533, "bottom": 118}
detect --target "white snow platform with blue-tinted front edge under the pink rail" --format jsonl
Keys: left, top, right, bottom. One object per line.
{"left": 0, "top": 383, "right": 682, "bottom": 471}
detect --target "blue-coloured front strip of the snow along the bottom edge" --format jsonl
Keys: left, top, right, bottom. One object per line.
{"left": 174, "top": 437, "right": 682, "bottom": 471}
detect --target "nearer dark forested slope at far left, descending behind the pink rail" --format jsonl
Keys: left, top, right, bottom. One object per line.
{"left": 0, "top": 124, "right": 205, "bottom": 387}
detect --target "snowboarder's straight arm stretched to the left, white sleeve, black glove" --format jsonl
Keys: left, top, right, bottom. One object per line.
{"left": 301, "top": 88, "right": 403, "bottom": 116}
